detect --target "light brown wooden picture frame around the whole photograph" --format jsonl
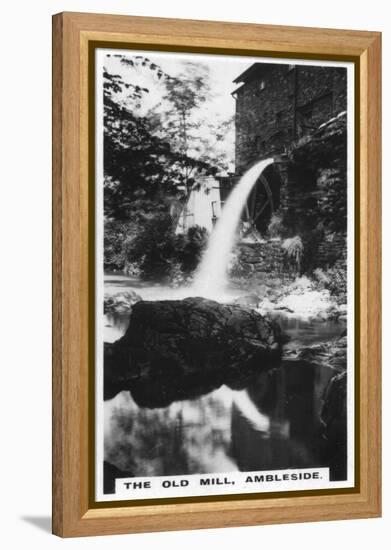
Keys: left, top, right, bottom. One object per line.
{"left": 53, "top": 13, "right": 381, "bottom": 537}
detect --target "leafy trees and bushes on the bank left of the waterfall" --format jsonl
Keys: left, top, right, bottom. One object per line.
{"left": 103, "top": 55, "right": 228, "bottom": 279}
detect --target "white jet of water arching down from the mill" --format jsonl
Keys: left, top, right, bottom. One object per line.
{"left": 193, "top": 158, "right": 273, "bottom": 298}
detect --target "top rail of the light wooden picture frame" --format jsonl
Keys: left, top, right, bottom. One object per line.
{"left": 63, "top": 12, "right": 378, "bottom": 56}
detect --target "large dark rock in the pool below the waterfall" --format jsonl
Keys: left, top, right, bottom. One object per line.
{"left": 104, "top": 298, "right": 283, "bottom": 407}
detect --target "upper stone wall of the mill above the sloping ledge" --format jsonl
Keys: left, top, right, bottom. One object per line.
{"left": 233, "top": 63, "right": 346, "bottom": 173}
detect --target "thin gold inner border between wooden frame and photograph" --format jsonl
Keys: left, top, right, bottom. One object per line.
{"left": 88, "top": 40, "right": 360, "bottom": 508}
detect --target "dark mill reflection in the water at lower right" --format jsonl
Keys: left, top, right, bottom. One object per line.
{"left": 231, "top": 361, "right": 335, "bottom": 477}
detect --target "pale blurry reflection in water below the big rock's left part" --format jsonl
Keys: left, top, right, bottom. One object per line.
{"left": 105, "top": 387, "right": 237, "bottom": 484}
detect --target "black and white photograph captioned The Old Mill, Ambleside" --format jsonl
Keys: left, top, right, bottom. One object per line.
{"left": 95, "top": 48, "right": 355, "bottom": 501}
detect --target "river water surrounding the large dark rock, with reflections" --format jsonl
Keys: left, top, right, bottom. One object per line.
{"left": 104, "top": 275, "right": 346, "bottom": 486}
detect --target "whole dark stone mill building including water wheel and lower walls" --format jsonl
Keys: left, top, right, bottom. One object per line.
{"left": 230, "top": 63, "right": 347, "bottom": 278}
